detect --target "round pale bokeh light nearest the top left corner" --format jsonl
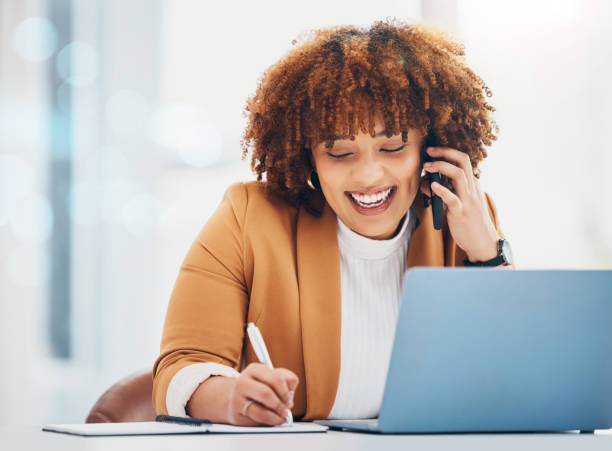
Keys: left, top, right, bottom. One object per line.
{"left": 13, "top": 17, "right": 57, "bottom": 62}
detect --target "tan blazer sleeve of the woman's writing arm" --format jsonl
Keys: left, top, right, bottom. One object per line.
{"left": 153, "top": 183, "right": 248, "bottom": 414}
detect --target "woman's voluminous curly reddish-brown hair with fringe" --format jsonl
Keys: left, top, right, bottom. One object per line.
{"left": 241, "top": 19, "right": 499, "bottom": 214}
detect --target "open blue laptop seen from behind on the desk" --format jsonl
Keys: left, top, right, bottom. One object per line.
{"left": 316, "top": 268, "right": 612, "bottom": 433}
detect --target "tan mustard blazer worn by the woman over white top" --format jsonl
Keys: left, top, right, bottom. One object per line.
{"left": 153, "top": 182, "right": 503, "bottom": 421}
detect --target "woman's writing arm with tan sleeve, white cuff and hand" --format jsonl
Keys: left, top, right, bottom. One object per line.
{"left": 153, "top": 183, "right": 298, "bottom": 426}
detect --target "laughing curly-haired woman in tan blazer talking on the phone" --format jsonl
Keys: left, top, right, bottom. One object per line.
{"left": 153, "top": 17, "right": 511, "bottom": 425}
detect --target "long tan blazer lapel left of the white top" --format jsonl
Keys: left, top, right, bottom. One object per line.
{"left": 297, "top": 204, "right": 341, "bottom": 421}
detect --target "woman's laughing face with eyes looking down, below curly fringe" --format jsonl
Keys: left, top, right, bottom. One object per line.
{"left": 312, "top": 121, "right": 423, "bottom": 240}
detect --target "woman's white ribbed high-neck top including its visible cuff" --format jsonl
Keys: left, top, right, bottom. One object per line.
{"left": 166, "top": 210, "right": 416, "bottom": 419}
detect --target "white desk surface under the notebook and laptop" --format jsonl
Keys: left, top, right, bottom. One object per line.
{"left": 0, "top": 427, "right": 612, "bottom": 451}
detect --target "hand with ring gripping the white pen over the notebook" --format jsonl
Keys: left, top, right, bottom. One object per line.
{"left": 227, "top": 363, "right": 299, "bottom": 426}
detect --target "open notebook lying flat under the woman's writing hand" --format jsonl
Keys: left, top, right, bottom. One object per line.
{"left": 42, "top": 421, "right": 328, "bottom": 436}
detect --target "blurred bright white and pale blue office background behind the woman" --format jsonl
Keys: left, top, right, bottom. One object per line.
{"left": 0, "top": 0, "right": 612, "bottom": 425}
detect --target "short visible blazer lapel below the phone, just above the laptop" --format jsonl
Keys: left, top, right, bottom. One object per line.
{"left": 406, "top": 191, "right": 444, "bottom": 268}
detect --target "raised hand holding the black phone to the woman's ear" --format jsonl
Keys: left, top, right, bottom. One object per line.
{"left": 421, "top": 147, "right": 500, "bottom": 262}
